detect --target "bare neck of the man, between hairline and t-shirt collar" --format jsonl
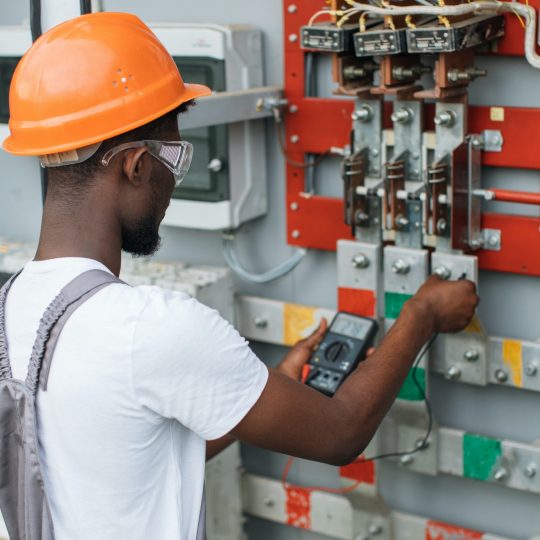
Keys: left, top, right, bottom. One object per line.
{"left": 34, "top": 193, "right": 122, "bottom": 276}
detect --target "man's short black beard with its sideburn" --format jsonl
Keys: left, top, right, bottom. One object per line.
{"left": 122, "top": 174, "right": 161, "bottom": 257}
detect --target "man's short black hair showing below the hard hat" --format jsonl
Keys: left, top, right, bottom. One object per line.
{"left": 48, "top": 100, "right": 195, "bottom": 188}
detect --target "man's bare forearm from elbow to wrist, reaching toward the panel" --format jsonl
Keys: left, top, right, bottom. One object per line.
{"left": 334, "top": 300, "right": 433, "bottom": 461}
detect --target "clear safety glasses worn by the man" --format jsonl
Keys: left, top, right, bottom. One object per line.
{"left": 101, "top": 141, "right": 193, "bottom": 187}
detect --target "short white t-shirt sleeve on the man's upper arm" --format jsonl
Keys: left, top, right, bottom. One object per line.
{"left": 132, "top": 287, "right": 268, "bottom": 440}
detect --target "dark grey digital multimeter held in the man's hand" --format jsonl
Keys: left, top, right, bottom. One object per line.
{"left": 305, "top": 311, "right": 379, "bottom": 396}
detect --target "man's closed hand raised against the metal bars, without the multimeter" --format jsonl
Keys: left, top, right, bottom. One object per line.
{"left": 411, "top": 276, "right": 480, "bottom": 333}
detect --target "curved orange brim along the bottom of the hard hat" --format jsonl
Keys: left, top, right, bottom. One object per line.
{"left": 2, "top": 83, "right": 212, "bottom": 156}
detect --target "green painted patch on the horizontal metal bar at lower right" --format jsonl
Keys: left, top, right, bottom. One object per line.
{"left": 463, "top": 433, "right": 502, "bottom": 480}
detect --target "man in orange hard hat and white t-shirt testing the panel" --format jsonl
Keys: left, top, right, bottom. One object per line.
{"left": 4, "top": 13, "right": 478, "bottom": 540}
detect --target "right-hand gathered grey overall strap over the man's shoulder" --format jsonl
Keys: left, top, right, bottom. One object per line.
{"left": 26, "top": 270, "right": 123, "bottom": 395}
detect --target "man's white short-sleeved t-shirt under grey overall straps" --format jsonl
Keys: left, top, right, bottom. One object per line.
{"left": 2, "top": 258, "right": 268, "bottom": 540}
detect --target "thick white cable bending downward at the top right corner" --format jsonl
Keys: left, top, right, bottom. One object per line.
{"left": 346, "top": 0, "right": 540, "bottom": 69}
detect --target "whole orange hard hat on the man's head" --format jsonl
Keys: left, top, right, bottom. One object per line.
{"left": 3, "top": 13, "right": 211, "bottom": 156}
